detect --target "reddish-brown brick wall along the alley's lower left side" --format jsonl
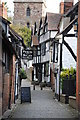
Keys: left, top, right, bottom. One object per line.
{"left": 2, "top": 55, "right": 15, "bottom": 114}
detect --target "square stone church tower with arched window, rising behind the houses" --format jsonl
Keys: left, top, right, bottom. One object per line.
{"left": 13, "top": 0, "right": 46, "bottom": 28}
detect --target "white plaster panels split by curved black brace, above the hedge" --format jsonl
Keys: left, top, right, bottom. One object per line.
{"left": 62, "top": 28, "right": 77, "bottom": 68}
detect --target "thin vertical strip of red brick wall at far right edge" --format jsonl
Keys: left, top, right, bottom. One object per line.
{"left": 76, "top": 1, "right": 80, "bottom": 112}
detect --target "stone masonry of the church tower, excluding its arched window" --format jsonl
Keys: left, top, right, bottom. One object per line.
{"left": 13, "top": 2, "right": 45, "bottom": 26}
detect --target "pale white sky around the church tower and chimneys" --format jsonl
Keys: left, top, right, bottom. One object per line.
{"left": 1, "top": 0, "right": 78, "bottom": 15}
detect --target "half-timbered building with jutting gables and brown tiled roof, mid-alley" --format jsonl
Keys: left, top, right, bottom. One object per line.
{"left": 32, "top": 13, "right": 61, "bottom": 87}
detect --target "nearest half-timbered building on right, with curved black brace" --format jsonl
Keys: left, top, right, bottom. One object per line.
{"left": 53, "top": 3, "right": 78, "bottom": 100}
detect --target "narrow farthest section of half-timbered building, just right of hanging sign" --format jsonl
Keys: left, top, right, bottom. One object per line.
{"left": 31, "top": 23, "right": 42, "bottom": 82}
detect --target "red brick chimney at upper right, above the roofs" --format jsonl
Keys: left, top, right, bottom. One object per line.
{"left": 60, "top": 0, "right": 74, "bottom": 14}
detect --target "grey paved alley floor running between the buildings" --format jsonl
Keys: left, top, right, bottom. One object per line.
{"left": 6, "top": 79, "right": 77, "bottom": 118}
